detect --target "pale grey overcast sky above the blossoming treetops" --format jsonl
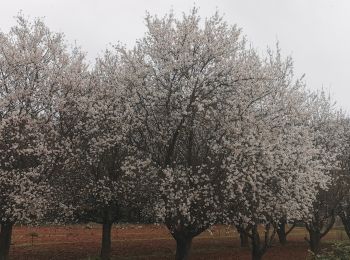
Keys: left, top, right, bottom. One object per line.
{"left": 0, "top": 0, "right": 350, "bottom": 112}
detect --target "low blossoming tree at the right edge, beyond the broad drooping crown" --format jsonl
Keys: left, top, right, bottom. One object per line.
{"left": 305, "top": 91, "right": 347, "bottom": 253}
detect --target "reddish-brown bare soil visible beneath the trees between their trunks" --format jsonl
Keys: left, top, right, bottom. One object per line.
{"left": 10, "top": 225, "right": 346, "bottom": 260}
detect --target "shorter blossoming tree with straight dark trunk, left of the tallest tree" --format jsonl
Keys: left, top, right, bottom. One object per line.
{"left": 54, "top": 51, "right": 152, "bottom": 259}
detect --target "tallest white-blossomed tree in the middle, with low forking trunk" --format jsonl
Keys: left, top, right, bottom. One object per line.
{"left": 115, "top": 9, "right": 250, "bottom": 259}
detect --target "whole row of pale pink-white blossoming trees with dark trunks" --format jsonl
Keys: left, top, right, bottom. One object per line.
{"left": 0, "top": 9, "right": 350, "bottom": 260}
